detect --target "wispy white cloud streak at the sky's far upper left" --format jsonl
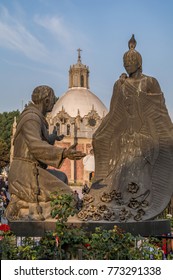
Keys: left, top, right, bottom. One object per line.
{"left": 0, "top": 6, "right": 48, "bottom": 61}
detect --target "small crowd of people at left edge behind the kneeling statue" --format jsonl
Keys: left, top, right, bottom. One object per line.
{"left": 0, "top": 175, "right": 10, "bottom": 224}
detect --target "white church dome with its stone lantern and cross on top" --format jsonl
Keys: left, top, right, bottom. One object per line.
{"left": 51, "top": 49, "right": 108, "bottom": 119}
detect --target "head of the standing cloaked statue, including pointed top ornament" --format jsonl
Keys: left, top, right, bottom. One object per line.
{"left": 123, "top": 34, "right": 142, "bottom": 75}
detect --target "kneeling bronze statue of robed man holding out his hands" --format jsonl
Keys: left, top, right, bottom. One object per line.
{"left": 6, "top": 86, "right": 85, "bottom": 221}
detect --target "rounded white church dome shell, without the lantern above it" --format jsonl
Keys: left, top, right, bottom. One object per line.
{"left": 51, "top": 87, "right": 108, "bottom": 118}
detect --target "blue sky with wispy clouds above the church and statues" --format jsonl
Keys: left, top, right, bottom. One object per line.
{"left": 0, "top": 0, "right": 173, "bottom": 118}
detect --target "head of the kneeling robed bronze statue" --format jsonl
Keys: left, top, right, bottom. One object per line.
{"left": 31, "top": 85, "right": 56, "bottom": 112}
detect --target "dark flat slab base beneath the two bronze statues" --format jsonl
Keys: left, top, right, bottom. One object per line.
{"left": 9, "top": 217, "right": 171, "bottom": 237}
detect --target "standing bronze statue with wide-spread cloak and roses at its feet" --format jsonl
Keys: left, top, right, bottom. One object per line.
{"left": 78, "top": 35, "right": 173, "bottom": 222}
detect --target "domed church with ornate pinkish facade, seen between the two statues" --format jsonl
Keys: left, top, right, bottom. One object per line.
{"left": 47, "top": 49, "right": 108, "bottom": 183}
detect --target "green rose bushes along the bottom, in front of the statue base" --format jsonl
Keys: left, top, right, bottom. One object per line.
{"left": 0, "top": 193, "right": 170, "bottom": 260}
